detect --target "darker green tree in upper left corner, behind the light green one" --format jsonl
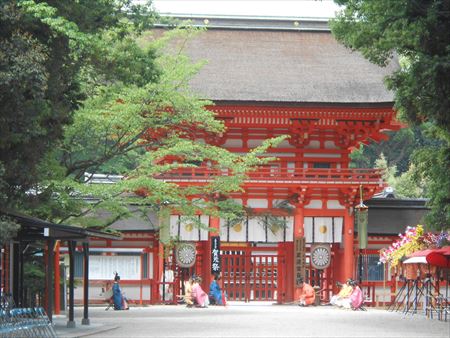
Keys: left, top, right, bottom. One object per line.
{"left": 0, "top": 0, "right": 157, "bottom": 207}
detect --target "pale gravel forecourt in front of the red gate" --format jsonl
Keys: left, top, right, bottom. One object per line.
{"left": 54, "top": 302, "right": 450, "bottom": 338}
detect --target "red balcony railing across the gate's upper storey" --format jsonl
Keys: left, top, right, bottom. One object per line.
{"left": 157, "top": 167, "right": 383, "bottom": 184}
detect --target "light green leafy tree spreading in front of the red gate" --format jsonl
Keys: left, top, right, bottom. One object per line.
{"left": 49, "top": 27, "right": 283, "bottom": 230}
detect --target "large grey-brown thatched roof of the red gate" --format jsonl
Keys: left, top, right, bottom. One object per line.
{"left": 164, "top": 16, "right": 398, "bottom": 103}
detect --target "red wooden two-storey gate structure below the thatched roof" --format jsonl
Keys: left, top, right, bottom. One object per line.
{"left": 155, "top": 105, "right": 400, "bottom": 302}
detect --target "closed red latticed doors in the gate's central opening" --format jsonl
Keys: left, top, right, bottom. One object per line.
{"left": 221, "top": 247, "right": 284, "bottom": 302}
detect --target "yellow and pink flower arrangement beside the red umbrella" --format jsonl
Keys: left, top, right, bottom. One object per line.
{"left": 380, "top": 225, "right": 450, "bottom": 268}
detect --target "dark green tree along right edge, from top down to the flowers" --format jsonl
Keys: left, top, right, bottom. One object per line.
{"left": 331, "top": 0, "right": 450, "bottom": 229}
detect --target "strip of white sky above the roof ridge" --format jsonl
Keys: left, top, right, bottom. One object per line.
{"left": 153, "top": 0, "right": 339, "bottom": 18}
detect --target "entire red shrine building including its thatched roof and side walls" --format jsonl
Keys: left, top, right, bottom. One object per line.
{"left": 76, "top": 16, "right": 408, "bottom": 303}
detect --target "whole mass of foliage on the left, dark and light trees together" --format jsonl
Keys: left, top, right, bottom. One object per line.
{"left": 0, "top": 0, "right": 282, "bottom": 235}
